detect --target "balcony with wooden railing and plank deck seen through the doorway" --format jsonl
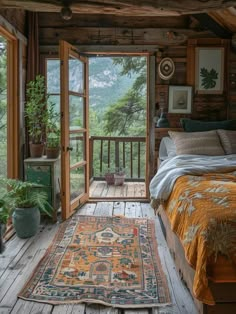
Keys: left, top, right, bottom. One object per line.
{"left": 89, "top": 136, "right": 146, "bottom": 198}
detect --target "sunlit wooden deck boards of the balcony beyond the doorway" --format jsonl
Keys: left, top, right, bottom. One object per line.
{"left": 89, "top": 181, "right": 146, "bottom": 198}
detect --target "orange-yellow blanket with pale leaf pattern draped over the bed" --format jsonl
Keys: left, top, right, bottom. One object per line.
{"left": 165, "top": 171, "right": 236, "bottom": 305}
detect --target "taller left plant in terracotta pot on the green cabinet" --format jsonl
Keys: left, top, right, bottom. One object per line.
{"left": 25, "top": 75, "right": 49, "bottom": 157}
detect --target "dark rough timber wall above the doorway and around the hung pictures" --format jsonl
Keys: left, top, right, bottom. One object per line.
{"left": 35, "top": 13, "right": 236, "bottom": 127}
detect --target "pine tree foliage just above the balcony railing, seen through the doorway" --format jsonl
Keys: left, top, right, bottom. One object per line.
{"left": 104, "top": 89, "right": 146, "bottom": 136}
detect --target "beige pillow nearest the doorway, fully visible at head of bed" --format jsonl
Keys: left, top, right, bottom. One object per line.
{"left": 168, "top": 131, "right": 225, "bottom": 156}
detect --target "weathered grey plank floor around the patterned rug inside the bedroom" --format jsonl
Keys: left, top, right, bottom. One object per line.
{"left": 0, "top": 202, "right": 197, "bottom": 314}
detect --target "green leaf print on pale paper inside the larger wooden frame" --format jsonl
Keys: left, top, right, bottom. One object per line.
{"left": 195, "top": 47, "right": 224, "bottom": 94}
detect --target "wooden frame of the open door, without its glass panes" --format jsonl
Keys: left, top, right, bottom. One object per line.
{"left": 60, "top": 41, "right": 89, "bottom": 220}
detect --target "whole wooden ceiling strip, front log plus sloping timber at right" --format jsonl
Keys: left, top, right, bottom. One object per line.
{"left": 0, "top": 0, "right": 236, "bottom": 34}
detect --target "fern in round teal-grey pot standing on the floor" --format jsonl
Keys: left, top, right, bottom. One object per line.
{"left": 0, "top": 178, "right": 53, "bottom": 238}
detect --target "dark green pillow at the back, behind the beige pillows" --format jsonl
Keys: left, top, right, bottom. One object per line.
{"left": 180, "top": 118, "right": 236, "bottom": 132}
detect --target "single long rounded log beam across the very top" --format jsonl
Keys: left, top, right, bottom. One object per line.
{"left": 0, "top": 0, "right": 236, "bottom": 16}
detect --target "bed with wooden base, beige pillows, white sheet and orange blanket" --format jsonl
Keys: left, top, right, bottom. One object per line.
{"left": 150, "top": 125, "right": 236, "bottom": 314}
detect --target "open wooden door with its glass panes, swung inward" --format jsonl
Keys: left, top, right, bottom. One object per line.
{"left": 60, "top": 41, "right": 89, "bottom": 220}
